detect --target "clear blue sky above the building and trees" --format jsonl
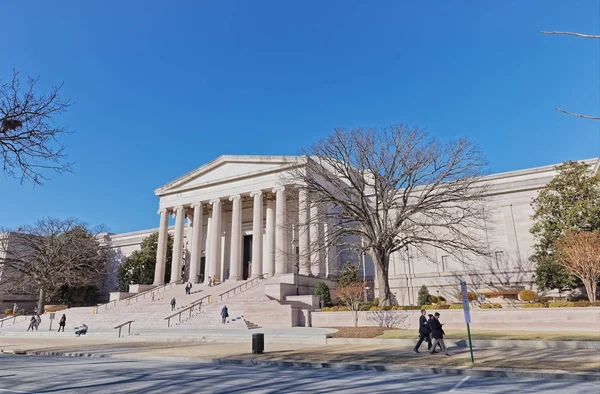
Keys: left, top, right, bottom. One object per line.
{"left": 0, "top": 0, "right": 600, "bottom": 232}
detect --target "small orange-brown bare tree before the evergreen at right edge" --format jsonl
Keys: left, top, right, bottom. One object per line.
{"left": 555, "top": 231, "right": 600, "bottom": 302}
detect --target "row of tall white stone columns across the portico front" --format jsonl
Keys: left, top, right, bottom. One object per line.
{"left": 154, "top": 187, "right": 286, "bottom": 285}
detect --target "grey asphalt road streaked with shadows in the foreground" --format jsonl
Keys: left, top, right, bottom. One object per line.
{"left": 0, "top": 355, "right": 598, "bottom": 394}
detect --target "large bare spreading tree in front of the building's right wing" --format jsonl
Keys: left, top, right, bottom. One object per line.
{"left": 290, "top": 125, "right": 487, "bottom": 306}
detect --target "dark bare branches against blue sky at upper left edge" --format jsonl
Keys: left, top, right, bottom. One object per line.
{"left": 0, "top": 71, "right": 71, "bottom": 185}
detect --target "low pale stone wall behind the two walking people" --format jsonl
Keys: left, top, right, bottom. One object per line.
{"left": 310, "top": 307, "right": 600, "bottom": 330}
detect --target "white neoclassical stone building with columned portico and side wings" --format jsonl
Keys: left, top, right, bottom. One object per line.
{"left": 106, "top": 156, "right": 600, "bottom": 304}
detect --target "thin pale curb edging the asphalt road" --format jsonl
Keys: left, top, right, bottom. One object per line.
{"left": 2, "top": 350, "right": 600, "bottom": 381}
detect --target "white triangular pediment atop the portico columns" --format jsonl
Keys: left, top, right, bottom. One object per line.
{"left": 154, "top": 156, "right": 300, "bottom": 196}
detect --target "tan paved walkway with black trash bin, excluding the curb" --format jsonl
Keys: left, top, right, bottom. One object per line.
{"left": 0, "top": 337, "right": 600, "bottom": 373}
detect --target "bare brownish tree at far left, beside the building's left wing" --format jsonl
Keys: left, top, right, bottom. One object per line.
{"left": 0, "top": 218, "right": 106, "bottom": 312}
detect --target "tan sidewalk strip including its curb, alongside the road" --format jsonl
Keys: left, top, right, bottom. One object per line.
{"left": 0, "top": 337, "right": 600, "bottom": 380}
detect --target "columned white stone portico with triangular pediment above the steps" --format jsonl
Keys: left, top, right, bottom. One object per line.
{"left": 154, "top": 156, "right": 337, "bottom": 285}
